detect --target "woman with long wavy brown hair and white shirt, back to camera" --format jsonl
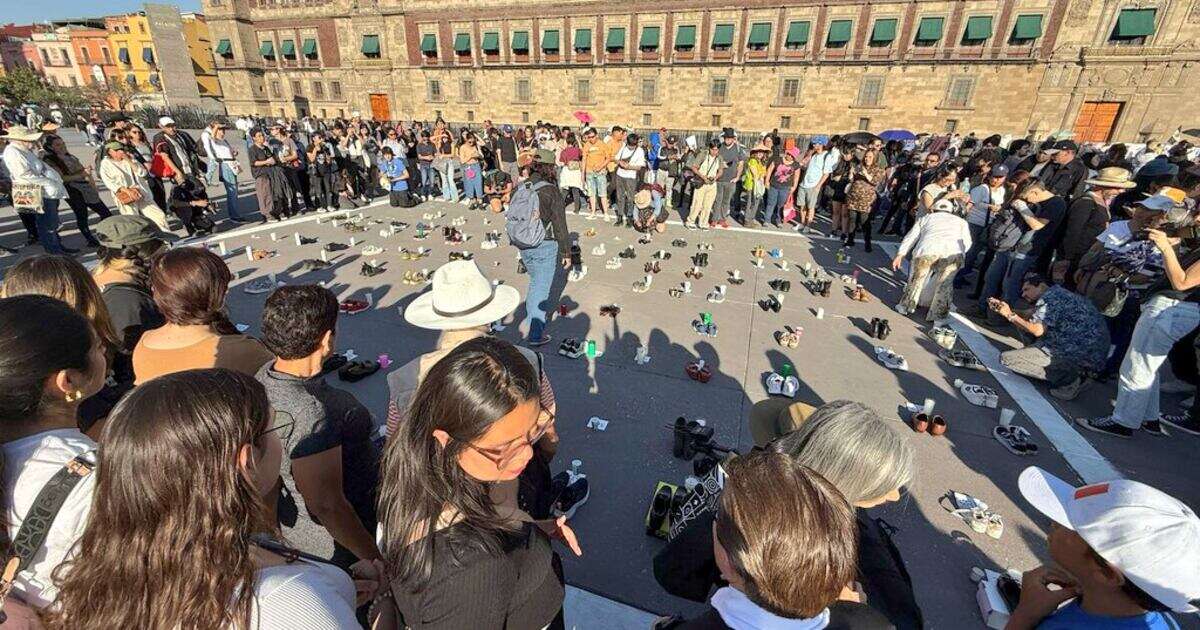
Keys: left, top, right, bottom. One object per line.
{"left": 49, "top": 368, "right": 359, "bottom": 630}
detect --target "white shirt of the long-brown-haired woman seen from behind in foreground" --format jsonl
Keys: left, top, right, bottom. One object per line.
{"left": 243, "top": 560, "right": 361, "bottom": 630}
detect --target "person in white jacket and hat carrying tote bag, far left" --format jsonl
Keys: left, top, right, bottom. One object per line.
{"left": 4, "top": 125, "right": 78, "bottom": 253}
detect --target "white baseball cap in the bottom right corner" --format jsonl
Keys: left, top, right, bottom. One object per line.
{"left": 1018, "top": 466, "right": 1200, "bottom": 613}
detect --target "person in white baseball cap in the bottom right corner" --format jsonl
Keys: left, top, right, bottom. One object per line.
{"left": 1006, "top": 467, "right": 1200, "bottom": 630}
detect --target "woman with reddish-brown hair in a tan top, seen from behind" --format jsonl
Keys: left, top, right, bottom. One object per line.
{"left": 133, "top": 247, "right": 274, "bottom": 385}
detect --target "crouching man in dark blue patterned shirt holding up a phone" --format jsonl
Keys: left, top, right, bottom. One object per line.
{"left": 988, "top": 274, "right": 1109, "bottom": 400}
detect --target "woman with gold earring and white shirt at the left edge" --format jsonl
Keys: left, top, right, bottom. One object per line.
{"left": 0, "top": 295, "right": 106, "bottom": 612}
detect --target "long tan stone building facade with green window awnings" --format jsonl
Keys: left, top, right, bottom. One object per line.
{"left": 204, "top": 0, "right": 1200, "bottom": 142}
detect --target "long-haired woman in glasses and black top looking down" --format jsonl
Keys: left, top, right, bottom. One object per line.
{"left": 379, "top": 337, "right": 581, "bottom": 630}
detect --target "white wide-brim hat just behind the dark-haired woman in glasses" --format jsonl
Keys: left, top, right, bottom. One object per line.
{"left": 404, "top": 260, "right": 521, "bottom": 330}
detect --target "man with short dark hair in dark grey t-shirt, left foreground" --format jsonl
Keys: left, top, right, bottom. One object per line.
{"left": 256, "top": 284, "right": 380, "bottom": 569}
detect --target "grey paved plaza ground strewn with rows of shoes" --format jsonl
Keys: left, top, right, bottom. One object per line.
{"left": 0, "top": 134, "right": 1200, "bottom": 629}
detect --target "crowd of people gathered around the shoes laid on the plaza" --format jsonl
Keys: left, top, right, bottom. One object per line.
{"left": 0, "top": 102, "right": 1200, "bottom": 630}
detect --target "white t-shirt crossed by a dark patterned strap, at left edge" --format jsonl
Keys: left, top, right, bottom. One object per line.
{"left": 2, "top": 428, "right": 96, "bottom": 608}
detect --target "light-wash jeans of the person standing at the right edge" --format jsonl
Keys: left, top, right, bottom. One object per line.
{"left": 1112, "top": 295, "right": 1200, "bottom": 428}
